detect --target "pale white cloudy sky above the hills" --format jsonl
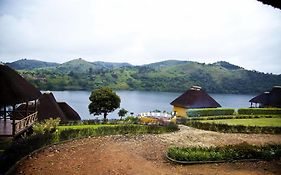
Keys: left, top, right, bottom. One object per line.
{"left": 0, "top": 0, "right": 281, "bottom": 74}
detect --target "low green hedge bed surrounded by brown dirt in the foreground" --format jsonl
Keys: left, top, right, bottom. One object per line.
{"left": 167, "top": 143, "right": 281, "bottom": 161}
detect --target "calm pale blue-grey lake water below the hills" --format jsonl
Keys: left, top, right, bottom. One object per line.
{"left": 50, "top": 91, "right": 255, "bottom": 119}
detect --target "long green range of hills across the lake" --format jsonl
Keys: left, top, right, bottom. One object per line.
{"left": 9, "top": 59, "right": 281, "bottom": 94}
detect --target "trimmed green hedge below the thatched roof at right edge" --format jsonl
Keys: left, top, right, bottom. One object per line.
{"left": 238, "top": 108, "right": 281, "bottom": 115}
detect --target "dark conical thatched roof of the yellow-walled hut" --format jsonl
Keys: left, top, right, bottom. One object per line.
{"left": 171, "top": 86, "right": 221, "bottom": 108}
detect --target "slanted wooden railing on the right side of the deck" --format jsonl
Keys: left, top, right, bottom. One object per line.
{"left": 14, "top": 112, "right": 37, "bottom": 134}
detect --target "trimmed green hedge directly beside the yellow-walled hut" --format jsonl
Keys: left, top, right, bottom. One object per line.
{"left": 187, "top": 108, "right": 235, "bottom": 117}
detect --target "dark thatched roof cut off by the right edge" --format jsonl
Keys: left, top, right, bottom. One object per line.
{"left": 249, "top": 86, "right": 281, "bottom": 107}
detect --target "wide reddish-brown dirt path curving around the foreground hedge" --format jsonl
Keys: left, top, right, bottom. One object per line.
{"left": 10, "top": 126, "right": 281, "bottom": 175}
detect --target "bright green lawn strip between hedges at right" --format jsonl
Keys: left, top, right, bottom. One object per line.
{"left": 200, "top": 118, "right": 281, "bottom": 127}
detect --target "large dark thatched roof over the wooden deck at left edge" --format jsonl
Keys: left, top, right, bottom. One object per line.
{"left": 0, "top": 64, "right": 41, "bottom": 106}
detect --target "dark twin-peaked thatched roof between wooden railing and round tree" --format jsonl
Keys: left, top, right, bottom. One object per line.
{"left": 38, "top": 93, "right": 80, "bottom": 121}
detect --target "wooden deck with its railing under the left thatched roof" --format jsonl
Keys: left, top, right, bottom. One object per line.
{"left": 0, "top": 112, "right": 37, "bottom": 137}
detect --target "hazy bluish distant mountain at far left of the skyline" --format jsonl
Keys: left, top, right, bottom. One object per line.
{"left": 6, "top": 59, "right": 59, "bottom": 70}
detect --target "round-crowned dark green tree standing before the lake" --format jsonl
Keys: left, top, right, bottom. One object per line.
{"left": 88, "top": 87, "right": 121, "bottom": 123}
